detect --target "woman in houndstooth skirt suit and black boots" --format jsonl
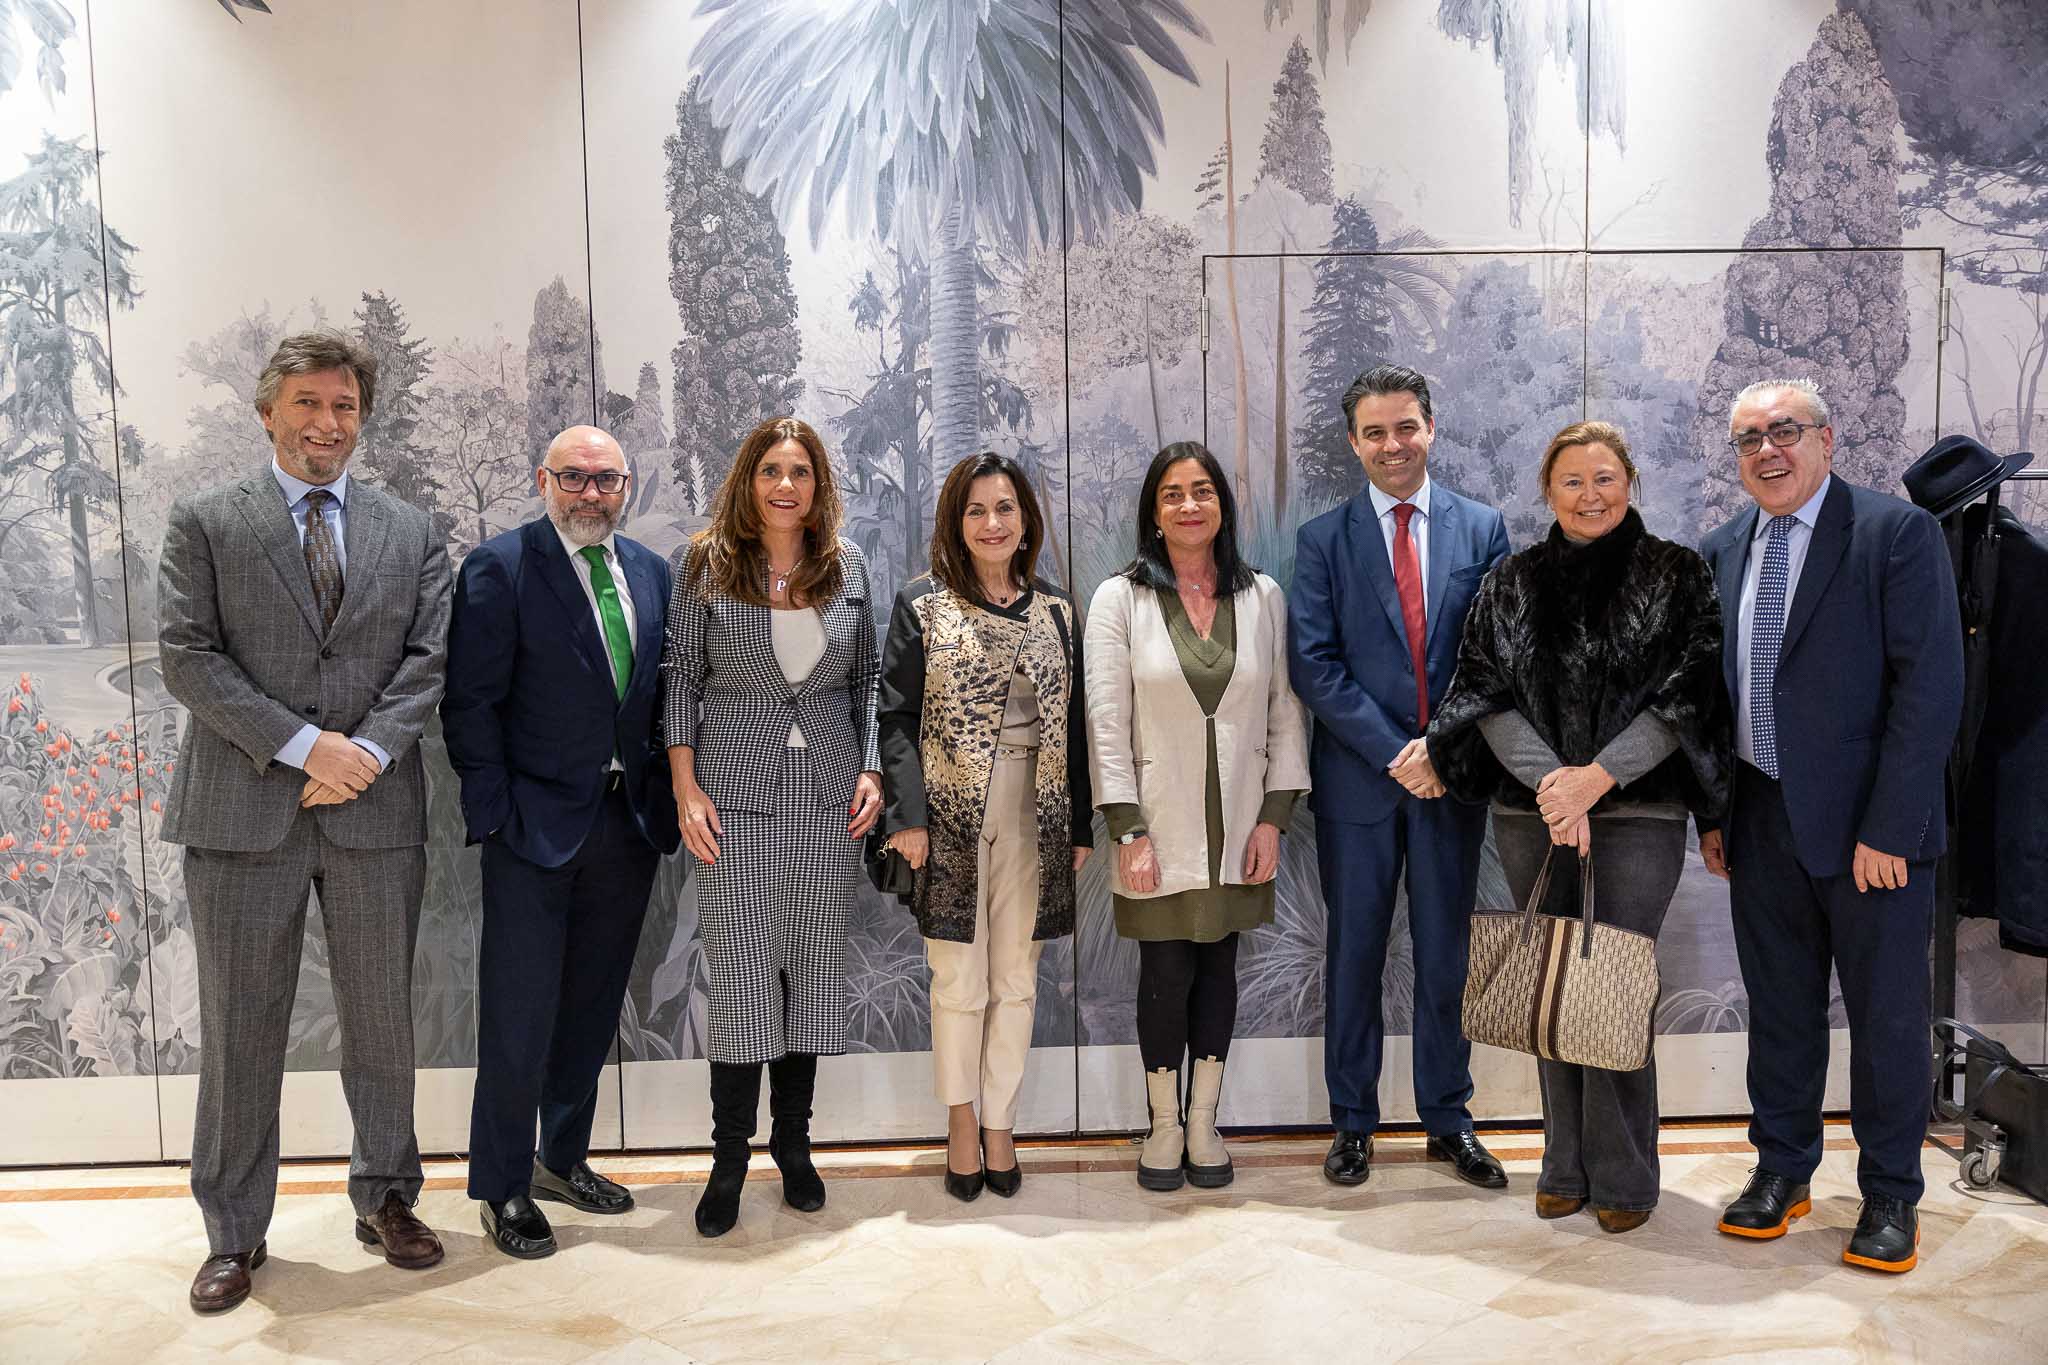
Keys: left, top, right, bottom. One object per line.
{"left": 662, "top": 417, "right": 881, "bottom": 1236}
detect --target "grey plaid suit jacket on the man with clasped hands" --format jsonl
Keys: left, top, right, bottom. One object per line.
{"left": 158, "top": 467, "right": 449, "bottom": 853}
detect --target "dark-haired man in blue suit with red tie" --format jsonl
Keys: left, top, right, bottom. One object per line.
{"left": 1288, "top": 364, "right": 1507, "bottom": 1189}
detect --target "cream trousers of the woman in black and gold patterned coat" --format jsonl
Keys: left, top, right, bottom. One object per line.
{"left": 924, "top": 749, "right": 1044, "bottom": 1132}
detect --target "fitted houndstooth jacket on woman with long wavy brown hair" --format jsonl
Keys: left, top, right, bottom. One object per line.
{"left": 662, "top": 538, "right": 883, "bottom": 814}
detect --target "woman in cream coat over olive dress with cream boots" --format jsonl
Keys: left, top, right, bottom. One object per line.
{"left": 1085, "top": 442, "right": 1309, "bottom": 1189}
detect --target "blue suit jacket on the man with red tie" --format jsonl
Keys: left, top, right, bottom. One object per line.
{"left": 1288, "top": 483, "right": 1507, "bottom": 825}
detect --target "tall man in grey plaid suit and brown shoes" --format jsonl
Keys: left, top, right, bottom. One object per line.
{"left": 158, "top": 332, "right": 449, "bottom": 1312}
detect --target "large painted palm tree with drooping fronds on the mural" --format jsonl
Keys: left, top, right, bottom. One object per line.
{"left": 692, "top": 0, "right": 1208, "bottom": 497}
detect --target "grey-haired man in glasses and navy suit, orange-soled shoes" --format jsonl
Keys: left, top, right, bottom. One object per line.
{"left": 1700, "top": 379, "right": 1962, "bottom": 1273}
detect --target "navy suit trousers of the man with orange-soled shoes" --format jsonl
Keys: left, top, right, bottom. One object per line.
{"left": 1729, "top": 763, "right": 1933, "bottom": 1203}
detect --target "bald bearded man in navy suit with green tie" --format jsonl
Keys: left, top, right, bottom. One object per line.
{"left": 440, "top": 426, "right": 680, "bottom": 1259}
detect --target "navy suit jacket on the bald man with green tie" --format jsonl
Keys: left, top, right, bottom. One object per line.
{"left": 440, "top": 518, "right": 680, "bottom": 868}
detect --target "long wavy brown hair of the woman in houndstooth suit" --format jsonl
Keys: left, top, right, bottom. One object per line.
{"left": 684, "top": 417, "right": 846, "bottom": 606}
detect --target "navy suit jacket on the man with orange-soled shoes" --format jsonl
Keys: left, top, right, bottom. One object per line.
{"left": 1700, "top": 475, "right": 1962, "bottom": 876}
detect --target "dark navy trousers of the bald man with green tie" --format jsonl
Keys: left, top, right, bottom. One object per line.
{"left": 469, "top": 790, "right": 659, "bottom": 1199}
